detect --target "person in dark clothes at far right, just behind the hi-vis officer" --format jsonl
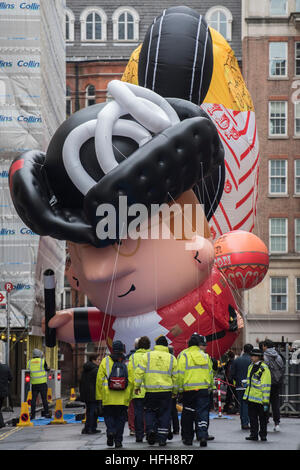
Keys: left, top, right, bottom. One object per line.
{"left": 262, "top": 339, "right": 284, "bottom": 432}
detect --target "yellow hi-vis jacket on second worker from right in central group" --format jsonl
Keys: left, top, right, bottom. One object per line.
{"left": 134, "top": 345, "right": 178, "bottom": 394}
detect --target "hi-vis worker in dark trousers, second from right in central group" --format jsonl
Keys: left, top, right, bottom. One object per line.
{"left": 134, "top": 336, "right": 177, "bottom": 446}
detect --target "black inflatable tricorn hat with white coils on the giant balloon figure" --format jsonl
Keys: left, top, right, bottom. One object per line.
{"left": 9, "top": 81, "right": 225, "bottom": 247}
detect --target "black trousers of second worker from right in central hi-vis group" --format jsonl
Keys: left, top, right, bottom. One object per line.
{"left": 145, "top": 392, "right": 172, "bottom": 442}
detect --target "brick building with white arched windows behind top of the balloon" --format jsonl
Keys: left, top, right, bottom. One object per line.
{"left": 66, "top": 0, "right": 241, "bottom": 114}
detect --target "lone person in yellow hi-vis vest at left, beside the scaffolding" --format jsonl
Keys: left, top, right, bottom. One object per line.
{"left": 27, "top": 349, "right": 50, "bottom": 419}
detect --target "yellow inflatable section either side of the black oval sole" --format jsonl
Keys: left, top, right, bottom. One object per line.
{"left": 122, "top": 28, "right": 254, "bottom": 111}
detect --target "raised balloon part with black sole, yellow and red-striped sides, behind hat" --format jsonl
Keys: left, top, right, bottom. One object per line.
{"left": 122, "top": 6, "right": 259, "bottom": 239}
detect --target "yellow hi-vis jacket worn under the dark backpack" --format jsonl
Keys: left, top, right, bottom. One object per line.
{"left": 96, "top": 356, "right": 133, "bottom": 406}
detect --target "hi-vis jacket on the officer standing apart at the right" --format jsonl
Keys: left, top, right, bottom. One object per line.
{"left": 243, "top": 362, "right": 271, "bottom": 405}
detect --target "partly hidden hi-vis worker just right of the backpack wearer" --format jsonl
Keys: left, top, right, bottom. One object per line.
{"left": 129, "top": 336, "right": 151, "bottom": 442}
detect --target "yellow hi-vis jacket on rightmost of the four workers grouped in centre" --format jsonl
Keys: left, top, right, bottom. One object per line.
{"left": 178, "top": 346, "right": 214, "bottom": 393}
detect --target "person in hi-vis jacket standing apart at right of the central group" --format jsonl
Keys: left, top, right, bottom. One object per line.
{"left": 243, "top": 348, "right": 271, "bottom": 441}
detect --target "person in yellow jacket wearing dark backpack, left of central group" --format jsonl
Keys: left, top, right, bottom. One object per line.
{"left": 96, "top": 341, "right": 133, "bottom": 448}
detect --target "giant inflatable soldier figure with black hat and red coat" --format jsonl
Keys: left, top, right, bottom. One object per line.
{"left": 9, "top": 7, "right": 264, "bottom": 358}
